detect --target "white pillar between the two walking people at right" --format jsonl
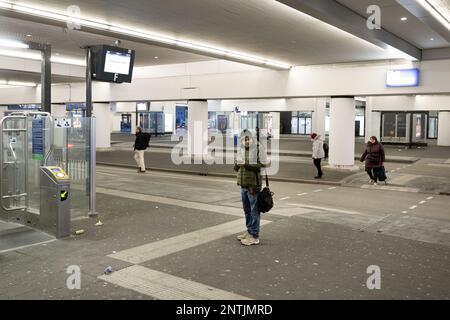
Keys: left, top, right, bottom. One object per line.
{"left": 329, "top": 97, "right": 358, "bottom": 170}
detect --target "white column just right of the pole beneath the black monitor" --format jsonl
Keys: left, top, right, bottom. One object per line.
{"left": 92, "top": 103, "right": 112, "bottom": 148}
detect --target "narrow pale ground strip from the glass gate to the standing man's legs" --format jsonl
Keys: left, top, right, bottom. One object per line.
{"left": 97, "top": 187, "right": 243, "bottom": 217}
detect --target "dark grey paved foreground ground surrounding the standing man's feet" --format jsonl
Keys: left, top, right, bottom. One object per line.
{"left": 0, "top": 166, "right": 450, "bottom": 300}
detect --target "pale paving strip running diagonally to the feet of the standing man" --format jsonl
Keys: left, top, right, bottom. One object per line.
{"left": 108, "top": 219, "right": 271, "bottom": 264}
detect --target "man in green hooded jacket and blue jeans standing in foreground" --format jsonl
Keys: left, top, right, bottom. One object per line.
{"left": 234, "top": 130, "right": 266, "bottom": 246}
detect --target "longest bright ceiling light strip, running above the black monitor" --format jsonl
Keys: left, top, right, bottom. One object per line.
{"left": 0, "top": 0, "right": 292, "bottom": 70}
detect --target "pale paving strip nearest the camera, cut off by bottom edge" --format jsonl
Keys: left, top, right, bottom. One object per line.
{"left": 99, "top": 266, "right": 251, "bottom": 300}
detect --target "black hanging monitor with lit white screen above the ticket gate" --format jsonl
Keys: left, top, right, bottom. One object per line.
{"left": 91, "top": 45, "right": 135, "bottom": 83}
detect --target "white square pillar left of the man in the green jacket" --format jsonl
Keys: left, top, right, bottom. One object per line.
{"left": 187, "top": 100, "right": 208, "bottom": 163}
